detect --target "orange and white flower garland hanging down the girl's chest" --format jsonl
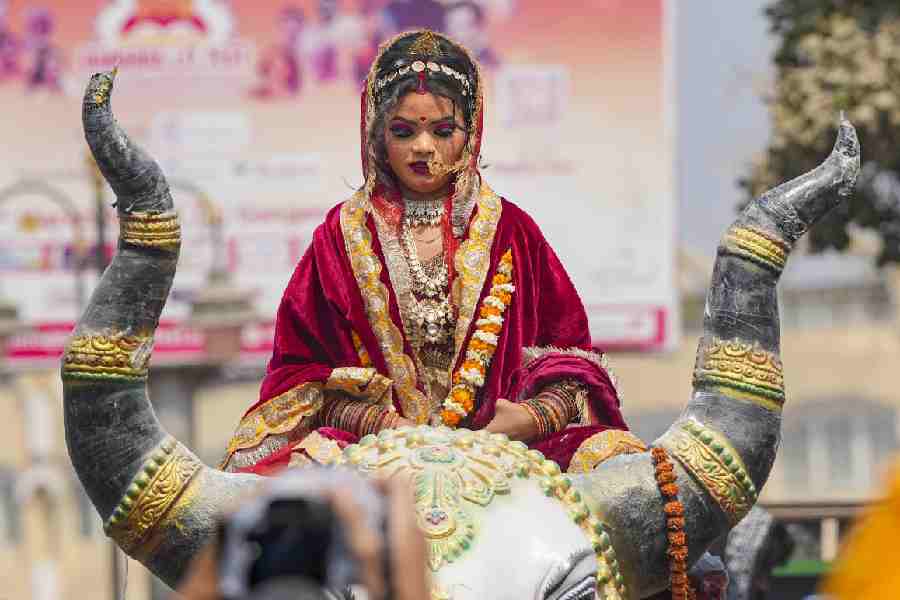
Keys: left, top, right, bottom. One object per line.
{"left": 441, "top": 250, "right": 516, "bottom": 427}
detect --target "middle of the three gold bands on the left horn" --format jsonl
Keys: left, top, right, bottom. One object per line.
{"left": 62, "top": 333, "right": 153, "bottom": 381}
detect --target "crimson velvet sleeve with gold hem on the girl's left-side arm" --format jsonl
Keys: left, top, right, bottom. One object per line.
{"left": 223, "top": 223, "right": 391, "bottom": 470}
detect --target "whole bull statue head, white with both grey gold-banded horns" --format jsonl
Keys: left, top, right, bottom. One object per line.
{"left": 62, "top": 73, "right": 859, "bottom": 600}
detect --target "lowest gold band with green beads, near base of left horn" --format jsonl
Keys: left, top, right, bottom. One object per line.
{"left": 103, "top": 437, "right": 201, "bottom": 555}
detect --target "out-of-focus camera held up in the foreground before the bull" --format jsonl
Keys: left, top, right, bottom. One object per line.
{"left": 217, "top": 468, "right": 387, "bottom": 600}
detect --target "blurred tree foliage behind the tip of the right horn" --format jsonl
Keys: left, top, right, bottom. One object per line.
{"left": 740, "top": 0, "right": 900, "bottom": 264}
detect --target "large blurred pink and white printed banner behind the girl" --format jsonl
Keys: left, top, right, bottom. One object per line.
{"left": 0, "top": 0, "right": 676, "bottom": 362}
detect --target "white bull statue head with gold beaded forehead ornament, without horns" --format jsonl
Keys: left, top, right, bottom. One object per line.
{"left": 337, "top": 426, "right": 625, "bottom": 600}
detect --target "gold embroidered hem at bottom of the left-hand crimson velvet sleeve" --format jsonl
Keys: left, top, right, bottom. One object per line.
{"left": 222, "top": 381, "right": 323, "bottom": 465}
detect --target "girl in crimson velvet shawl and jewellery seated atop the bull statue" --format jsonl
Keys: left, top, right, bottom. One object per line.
{"left": 223, "top": 30, "right": 625, "bottom": 473}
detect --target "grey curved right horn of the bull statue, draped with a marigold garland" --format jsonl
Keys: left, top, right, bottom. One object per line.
{"left": 573, "top": 118, "right": 860, "bottom": 598}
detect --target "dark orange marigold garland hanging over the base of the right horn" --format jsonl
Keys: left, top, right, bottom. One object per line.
{"left": 650, "top": 447, "right": 696, "bottom": 600}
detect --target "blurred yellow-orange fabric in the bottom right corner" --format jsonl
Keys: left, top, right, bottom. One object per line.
{"left": 822, "top": 460, "right": 900, "bottom": 600}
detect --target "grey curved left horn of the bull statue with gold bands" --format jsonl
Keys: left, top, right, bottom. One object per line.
{"left": 62, "top": 72, "right": 258, "bottom": 585}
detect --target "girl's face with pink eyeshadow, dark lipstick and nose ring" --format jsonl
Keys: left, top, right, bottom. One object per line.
{"left": 384, "top": 92, "right": 466, "bottom": 197}
